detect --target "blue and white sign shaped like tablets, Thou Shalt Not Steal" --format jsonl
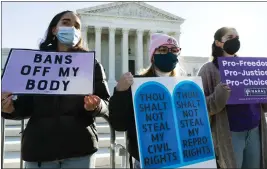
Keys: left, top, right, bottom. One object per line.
{"left": 132, "top": 77, "right": 217, "bottom": 168}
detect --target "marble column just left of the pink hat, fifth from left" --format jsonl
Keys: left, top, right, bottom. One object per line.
{"left": 135, "top": 29, "right": 144, "bottom": 73}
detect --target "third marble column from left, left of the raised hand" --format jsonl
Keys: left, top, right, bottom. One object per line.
{"left": 109, "top": 27, "right": 116, "bottom": 82}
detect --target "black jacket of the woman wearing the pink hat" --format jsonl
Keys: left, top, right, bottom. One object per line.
{"left": 109, "top": 75, "right": 150, "bottom": 161}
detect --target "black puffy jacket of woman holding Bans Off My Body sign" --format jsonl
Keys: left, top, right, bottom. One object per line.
{"left": 2, "top": 58, "right": 110, "bottom": 162}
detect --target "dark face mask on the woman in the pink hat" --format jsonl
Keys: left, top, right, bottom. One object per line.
{"left": 154, "top": 52, "right": 178, "bottom": 72}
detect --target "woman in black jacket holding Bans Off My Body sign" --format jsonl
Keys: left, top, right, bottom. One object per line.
{"left": 2, "top": 11, "right": 110, "bottom": 168}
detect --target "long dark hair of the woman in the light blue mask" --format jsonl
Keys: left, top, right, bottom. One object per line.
{"left": 39, "top": 10, "right": 87, "bottom": 51}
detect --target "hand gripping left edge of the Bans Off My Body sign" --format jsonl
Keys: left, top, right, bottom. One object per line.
{"left": 1, "top": 92, "right": 14, "bottom": 113}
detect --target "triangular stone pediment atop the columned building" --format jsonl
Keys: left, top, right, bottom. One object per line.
{"left": 77, "top": 2, "right": 184, "bottom": 22}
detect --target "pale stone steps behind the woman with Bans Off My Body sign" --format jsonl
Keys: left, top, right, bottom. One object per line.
{"left": 4, "top": 118, "right": 125, "bottom": 168}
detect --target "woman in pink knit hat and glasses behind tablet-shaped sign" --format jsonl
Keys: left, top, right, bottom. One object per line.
{"left": 109, "top": 34, "right": 184, "bottom": 168}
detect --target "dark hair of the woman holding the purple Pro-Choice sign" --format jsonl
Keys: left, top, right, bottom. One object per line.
{"left": 212, "top": 27, "right": 229, "bottom": 68}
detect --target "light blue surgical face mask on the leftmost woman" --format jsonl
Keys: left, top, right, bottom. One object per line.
{"left": 56, "top": 27, "right": 81, "bottom": 47}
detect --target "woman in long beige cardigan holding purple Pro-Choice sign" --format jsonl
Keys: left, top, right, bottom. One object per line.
{"left": 199, "top": 27, "right": 267, "bottom": 168}
